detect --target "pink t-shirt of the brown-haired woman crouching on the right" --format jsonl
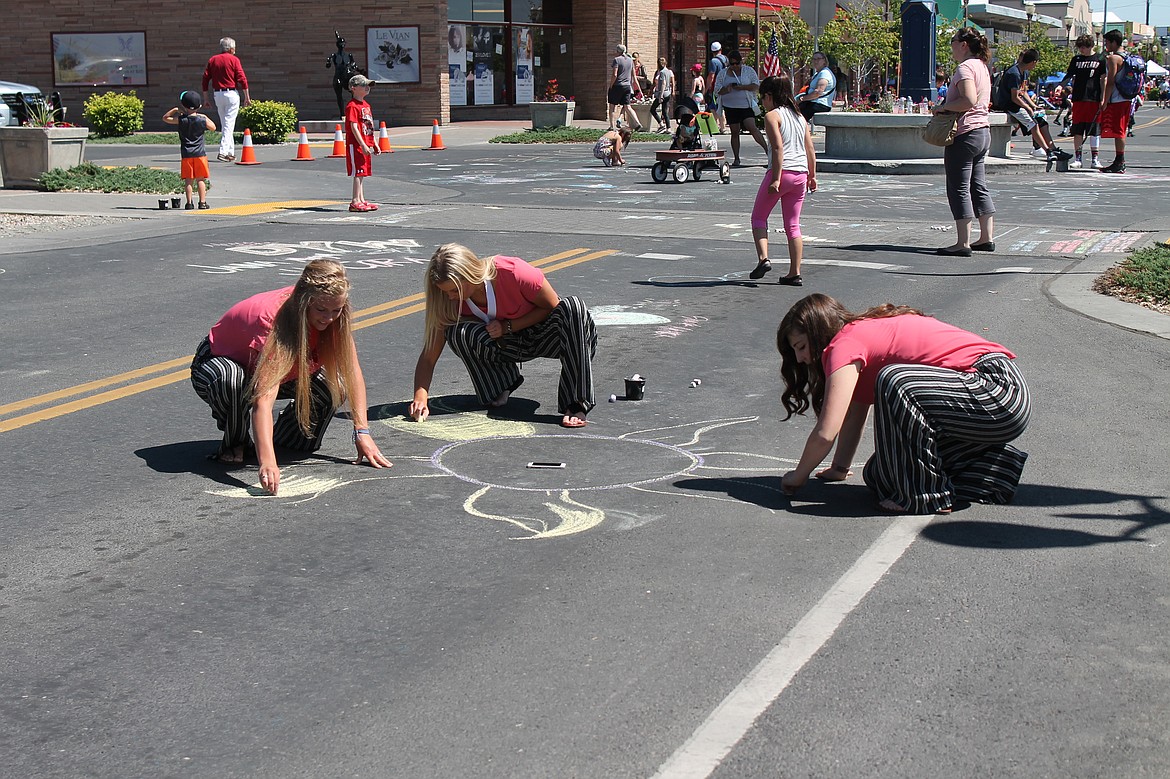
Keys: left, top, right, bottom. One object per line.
{"left": 820, "top": 313, "right": 1016, "bottom": 404}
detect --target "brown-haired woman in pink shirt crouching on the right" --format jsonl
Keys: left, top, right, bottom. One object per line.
{"left": 776, "top": 294, "right": 1031, "bottom": 513}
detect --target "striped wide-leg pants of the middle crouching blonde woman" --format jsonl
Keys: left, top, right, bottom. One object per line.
{"left": 447, "top": 297, "right": 597, "bottom": 414}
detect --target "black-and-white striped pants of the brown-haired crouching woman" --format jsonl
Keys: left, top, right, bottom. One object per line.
{"left": 863, "top": 353, "right": 1031, "bottom": 513}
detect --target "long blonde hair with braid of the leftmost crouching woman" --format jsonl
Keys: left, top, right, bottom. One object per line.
{"left": 248, "top": 260, "right": 357, "bottom": 435}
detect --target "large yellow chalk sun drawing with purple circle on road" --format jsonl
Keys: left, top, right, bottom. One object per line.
{"left": 206, "top": 398, "right": 796, "bottom": 540}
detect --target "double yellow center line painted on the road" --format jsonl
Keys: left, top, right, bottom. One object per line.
{"left": 0, "top": 249, "right": 618, "bottom": 433}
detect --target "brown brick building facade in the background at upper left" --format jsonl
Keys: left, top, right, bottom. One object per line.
{"left": 0, "top": 0, "right": 776, "bottom": 129}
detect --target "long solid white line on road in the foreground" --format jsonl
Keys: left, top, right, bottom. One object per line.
{"left": 654, "top": 516, "right": 934, "bottom": 779}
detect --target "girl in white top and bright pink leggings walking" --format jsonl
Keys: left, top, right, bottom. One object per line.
{"left": 749, "top": 75, "right": 817, "bottom": 287}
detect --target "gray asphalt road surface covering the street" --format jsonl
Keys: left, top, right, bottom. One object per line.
{"left": 0, "top": 115, "right": 1170, "bottom": 779}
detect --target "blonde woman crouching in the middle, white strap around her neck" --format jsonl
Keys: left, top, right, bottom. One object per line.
{"left": 410, "top": 243, "right": 597, "bottom": 427}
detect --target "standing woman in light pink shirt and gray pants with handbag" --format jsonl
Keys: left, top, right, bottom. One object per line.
{"left": 935, "top": 27, "right": 996, "bottom": 257}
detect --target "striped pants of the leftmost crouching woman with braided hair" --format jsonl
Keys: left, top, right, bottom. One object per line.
{"left": 191, "top": 338, "right": 337, "bottom": 451}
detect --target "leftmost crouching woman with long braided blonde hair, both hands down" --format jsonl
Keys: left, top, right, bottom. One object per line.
{"left": 191, "top": 260, "right": 391, "bottom": 495}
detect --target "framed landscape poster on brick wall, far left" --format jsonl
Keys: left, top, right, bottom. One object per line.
{"left": 53, "top": 33, "right": 146, "bottom": 87}
